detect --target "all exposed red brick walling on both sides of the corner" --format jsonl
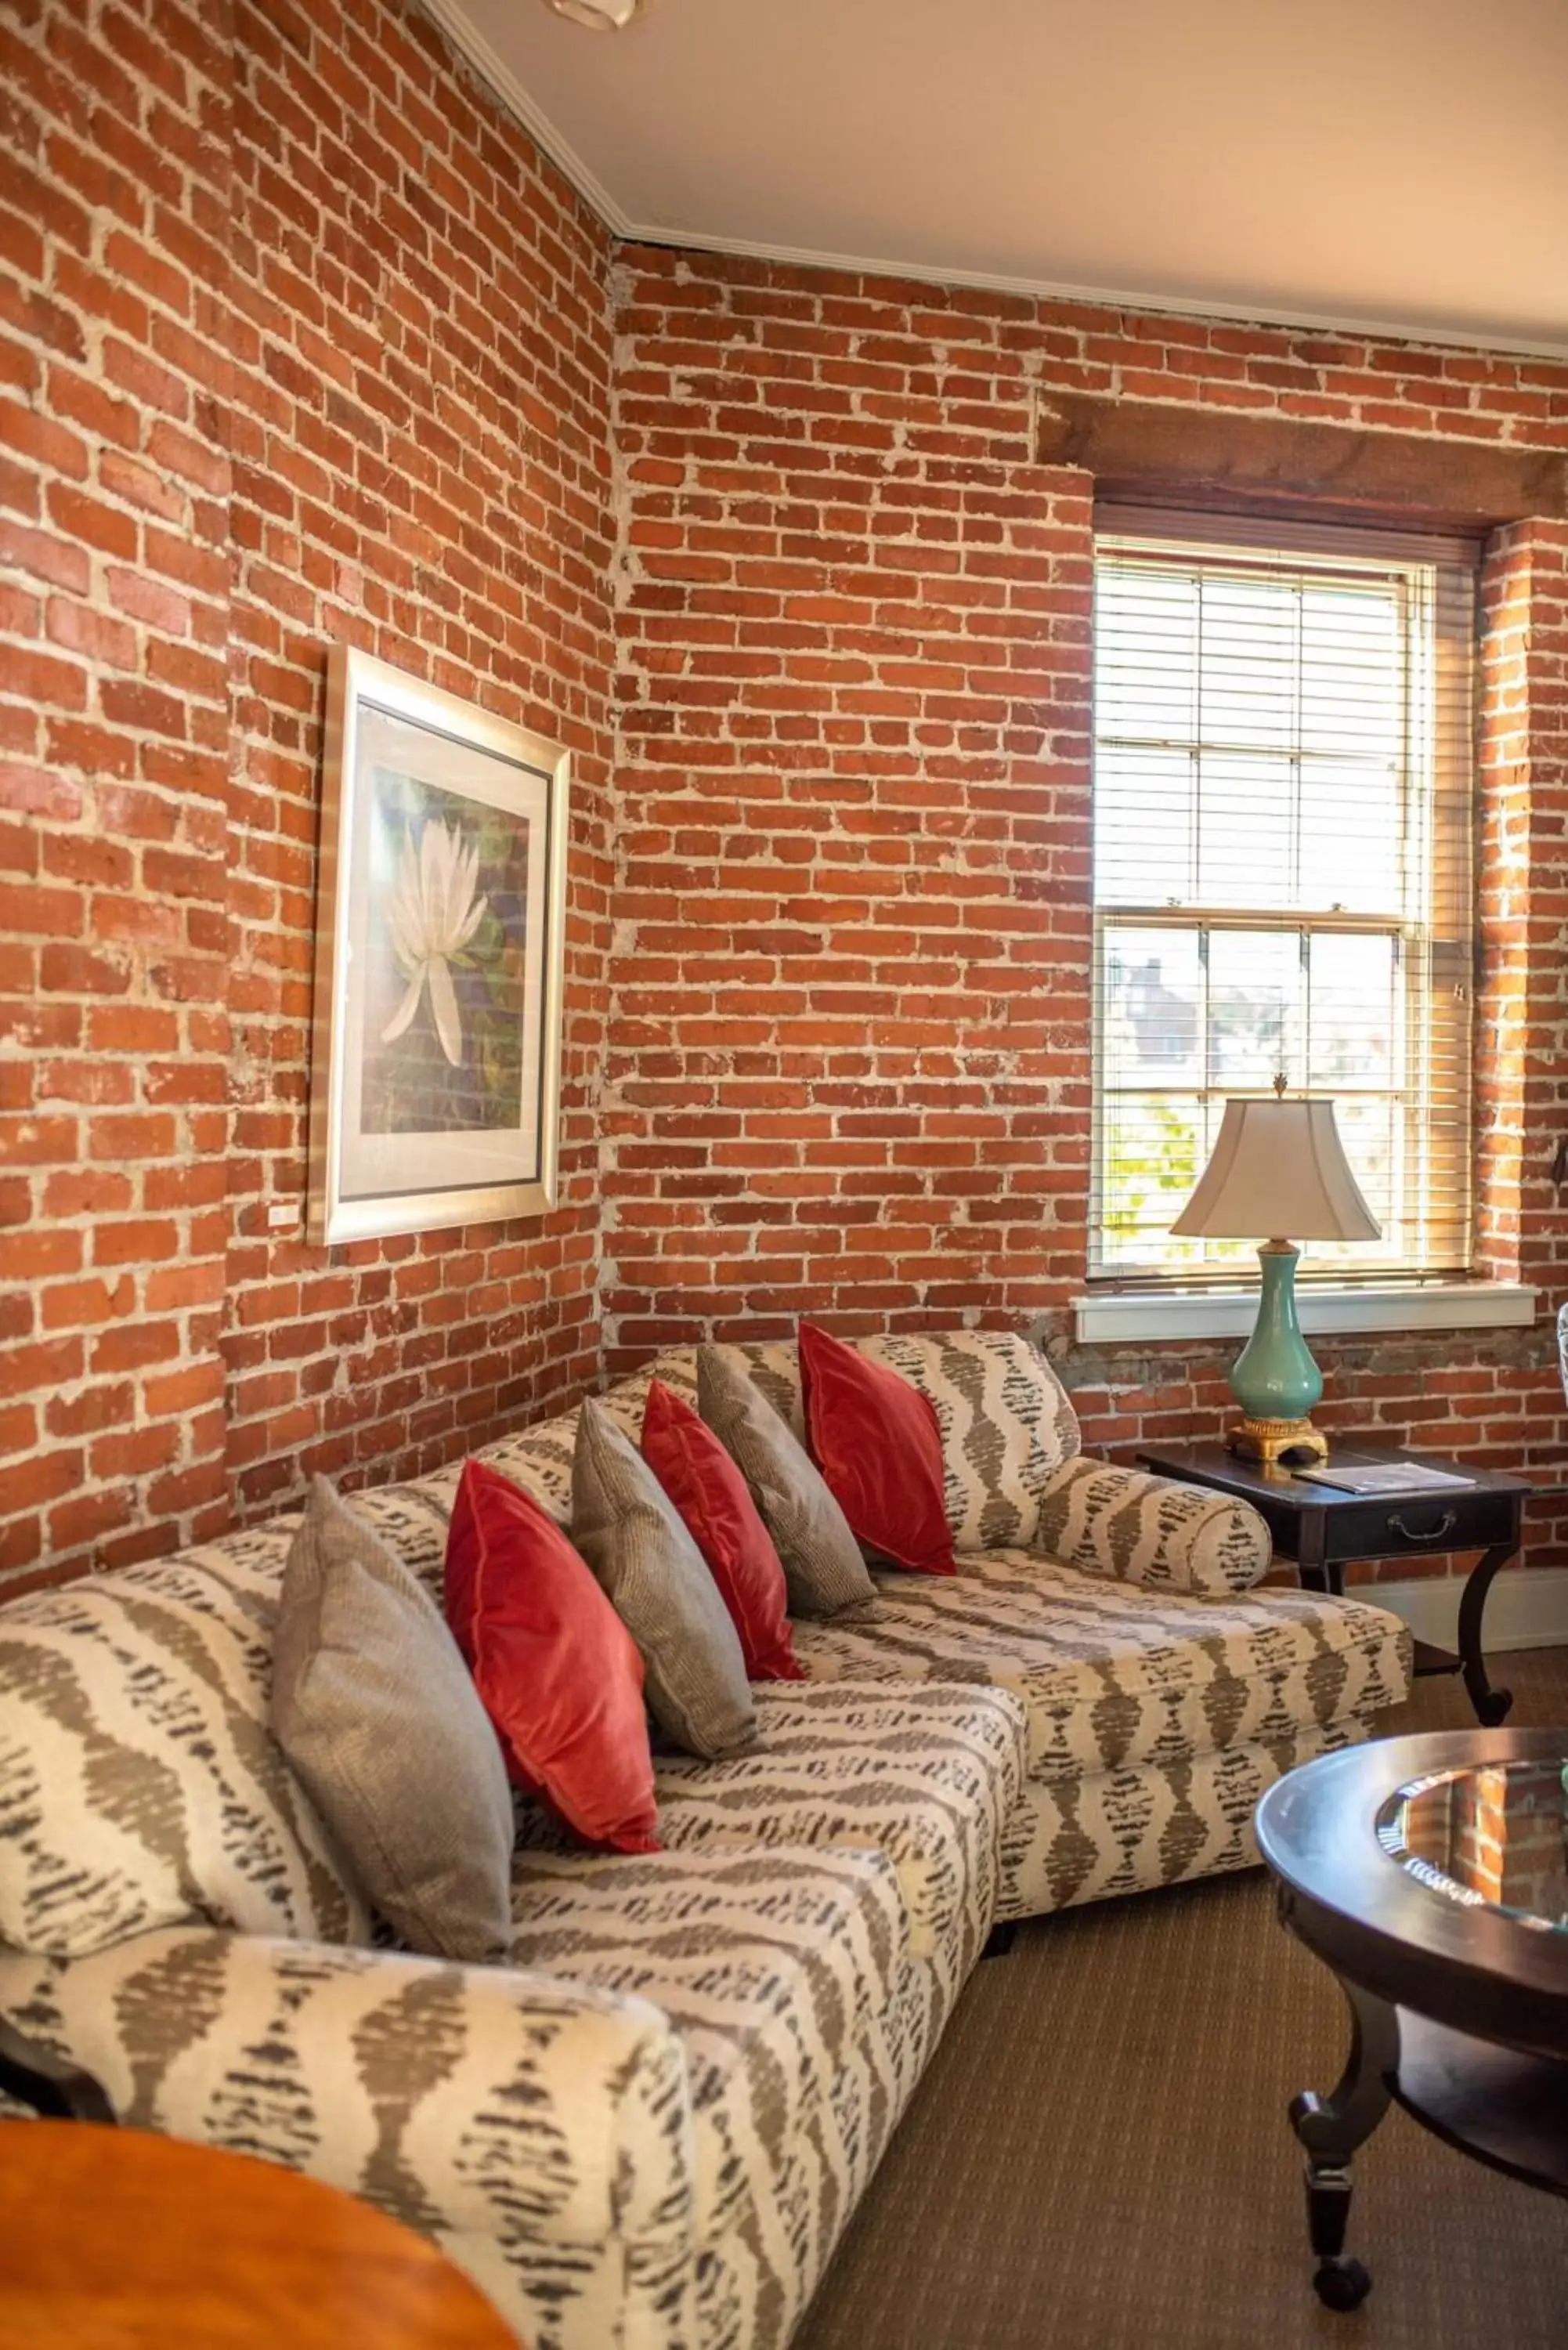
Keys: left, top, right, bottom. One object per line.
{"left": 0, "top": 36, "right": 1568, "bottom": 1586}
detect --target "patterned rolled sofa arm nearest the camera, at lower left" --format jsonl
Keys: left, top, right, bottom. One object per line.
{"left": 0, "top": 1927, "right": 693, "bottom": 2303}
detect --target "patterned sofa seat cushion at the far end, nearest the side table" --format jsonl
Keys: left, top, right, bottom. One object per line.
{"left": 797, "top": 1551, "right": 1411, "bottom": 1781}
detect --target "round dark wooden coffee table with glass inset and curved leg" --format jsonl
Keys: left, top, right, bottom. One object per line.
{"left": 1258, "top": 1730, "right": 1568, "bottom": 2310}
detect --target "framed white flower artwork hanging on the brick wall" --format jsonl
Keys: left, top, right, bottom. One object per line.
{"left": 308, "top": 646, "right": 569, "bottom": 1246}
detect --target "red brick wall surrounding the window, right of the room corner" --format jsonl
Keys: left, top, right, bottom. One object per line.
{"left": 604, "top": 247, "right": 1568, "bottom": 1572}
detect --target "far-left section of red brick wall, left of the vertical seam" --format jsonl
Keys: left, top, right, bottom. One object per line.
{"left": 0, "top": 0, "right": 233, "bottom": 1582}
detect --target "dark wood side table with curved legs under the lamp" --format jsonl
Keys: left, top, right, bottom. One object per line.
{"left": 1138, "top": 1445, "right": 1533, "bottom": 1730}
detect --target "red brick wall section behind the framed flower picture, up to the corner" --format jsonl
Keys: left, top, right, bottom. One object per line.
{"left": 226, "top": 0, "right": 613, "bottom": 1513}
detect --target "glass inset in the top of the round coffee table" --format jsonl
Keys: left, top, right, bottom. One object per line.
{"left": 1378, "top": 1758, "right": 1568, "bottom": 1934}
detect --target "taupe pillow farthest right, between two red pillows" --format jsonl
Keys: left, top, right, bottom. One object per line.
{"left": 695, "top": 1347, "right": 877, "bottom": 1617}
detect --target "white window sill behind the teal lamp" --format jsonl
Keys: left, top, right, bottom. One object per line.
{"left": 1075, "top": 1281, "right": 1540, "bottom": 1347}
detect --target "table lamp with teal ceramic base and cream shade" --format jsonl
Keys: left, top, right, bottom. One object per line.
{"left": 1171, "top": 1076, "right": 1380, "bottom": 1462}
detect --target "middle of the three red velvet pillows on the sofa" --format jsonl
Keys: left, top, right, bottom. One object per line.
{"left": 641, "top": 1379, "right": 807, "bottom": 1680}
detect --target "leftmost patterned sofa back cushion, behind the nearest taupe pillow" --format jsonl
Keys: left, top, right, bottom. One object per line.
{"left": 0, "top": 1518, "right": 369, "bottom": 1958}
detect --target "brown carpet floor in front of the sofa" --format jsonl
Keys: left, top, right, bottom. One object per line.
{"left": 797, "top": 1650, "right": 1568, "bottom": 2350}
